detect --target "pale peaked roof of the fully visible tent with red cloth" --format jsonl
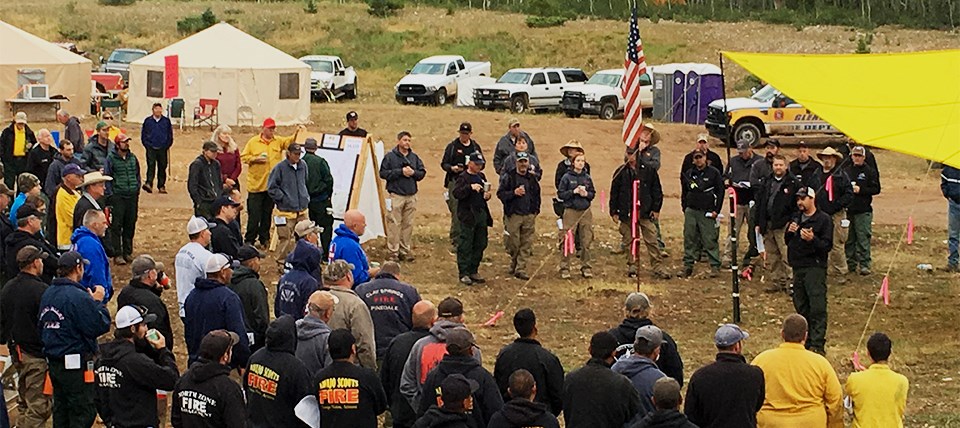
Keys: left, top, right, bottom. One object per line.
{"left": 132, "top": 22, "right": 310, "bottom": 70}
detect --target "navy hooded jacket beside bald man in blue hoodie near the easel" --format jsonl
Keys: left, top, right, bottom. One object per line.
{"left": 273, "top": 245, "right": 323, "bottom": 320}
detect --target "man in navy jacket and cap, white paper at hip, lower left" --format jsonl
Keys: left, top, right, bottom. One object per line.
{"left": 38, "top": 251, "right": 110, "bottom": 427}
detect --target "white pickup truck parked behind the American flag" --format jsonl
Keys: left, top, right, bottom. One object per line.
{"left": 560, "top": 68, "right": 653, "bottom": 120}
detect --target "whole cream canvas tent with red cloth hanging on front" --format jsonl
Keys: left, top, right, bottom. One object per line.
{"left": 124, "top": 22, "right": 310, "bottom": 126}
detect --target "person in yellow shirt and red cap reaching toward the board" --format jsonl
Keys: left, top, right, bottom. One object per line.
{"left": 240, "top": 117, "right": 306, "bottom": 247}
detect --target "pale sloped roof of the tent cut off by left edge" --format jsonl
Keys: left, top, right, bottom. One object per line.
{"left": 0, "top": 21, "right": 90, "bottom": 65}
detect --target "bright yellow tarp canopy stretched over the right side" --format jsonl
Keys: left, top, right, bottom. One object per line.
{"left": 723, "top": 50, "right": 960, "bottom": 167}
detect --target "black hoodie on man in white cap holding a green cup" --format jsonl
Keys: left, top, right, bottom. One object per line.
{"left": 96, "top": 339, "right": 180, "bottom": 427}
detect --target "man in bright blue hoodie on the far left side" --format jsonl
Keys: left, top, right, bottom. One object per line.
{"left": 70, "top": 210, "right": 113, "bottom": 300}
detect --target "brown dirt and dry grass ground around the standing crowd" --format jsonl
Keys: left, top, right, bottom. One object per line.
{"left": 16, "top": 103, "right": 960, "bottom": 426}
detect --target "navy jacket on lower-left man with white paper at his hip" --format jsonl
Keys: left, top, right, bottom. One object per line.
{"left": 37, "top": 278, "right": 110, "bottom": 358}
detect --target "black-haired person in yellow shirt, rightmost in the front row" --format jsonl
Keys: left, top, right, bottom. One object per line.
{"left": 844, "top": 333, "right": 910, "bottom": 428}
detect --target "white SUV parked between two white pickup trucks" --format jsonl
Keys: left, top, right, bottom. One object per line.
{"left": 473, "top": 68, "right": 587, "bottom": 113}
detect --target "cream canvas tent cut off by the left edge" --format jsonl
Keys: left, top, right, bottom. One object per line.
{"left": 0, "top": 21, "right": 91, "bottom": 122}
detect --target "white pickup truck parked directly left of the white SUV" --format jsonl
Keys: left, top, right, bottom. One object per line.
{"left": 394, "top": 55, "right": 490, "bottom": 105}
